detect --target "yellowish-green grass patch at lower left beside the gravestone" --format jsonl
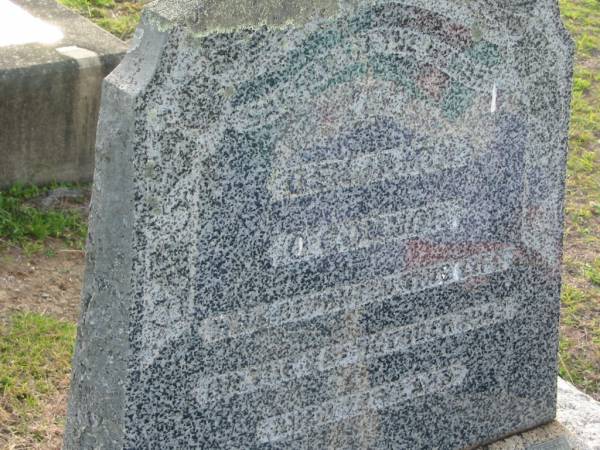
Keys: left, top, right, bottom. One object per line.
{"left": 0, "top": 313, "right": 76, "bottom": 448}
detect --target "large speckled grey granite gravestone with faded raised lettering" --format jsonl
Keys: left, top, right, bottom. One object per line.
{"left": 65, "top": 0, "right": 571, "bottom": 449}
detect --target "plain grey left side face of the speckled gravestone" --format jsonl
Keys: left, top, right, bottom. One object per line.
{"left": 63, "top": 14, "right": 168, "bottom": 450}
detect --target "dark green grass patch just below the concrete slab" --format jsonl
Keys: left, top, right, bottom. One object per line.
{"left": 0, "top": 184, "right": 87, "bottom": 251}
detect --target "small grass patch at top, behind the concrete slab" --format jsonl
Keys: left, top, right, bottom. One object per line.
{"left": 58, "top": 0, "right": 143, "bottom": 40}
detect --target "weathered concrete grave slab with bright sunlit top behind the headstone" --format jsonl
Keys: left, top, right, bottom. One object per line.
{"left": 0, "top": 0, "right": 127, "bottom": 186}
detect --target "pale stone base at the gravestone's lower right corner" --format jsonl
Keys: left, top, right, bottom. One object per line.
{"left": 481, "top": 378, "right": 600, "bottom": 450}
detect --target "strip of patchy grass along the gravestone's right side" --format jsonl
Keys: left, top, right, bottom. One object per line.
{"left": 560, "top": 0, "right": 600, "bottom": 399}
